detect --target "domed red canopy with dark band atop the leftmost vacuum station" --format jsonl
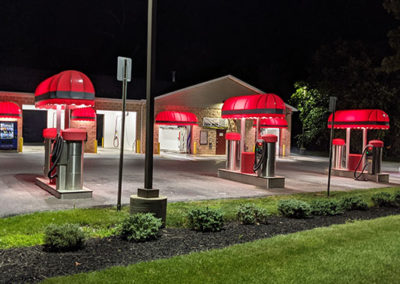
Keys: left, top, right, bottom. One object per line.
{"left": 35, "top": 70, "right": 94, "bottom": 108}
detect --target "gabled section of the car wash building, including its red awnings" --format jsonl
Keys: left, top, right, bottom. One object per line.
{"left": 154, "top": 75, "right": 297, "bottom": 156}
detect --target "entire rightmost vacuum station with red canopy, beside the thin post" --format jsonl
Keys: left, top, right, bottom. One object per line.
{"left": 328, "top": 109, "right": 389, "bottom": 183}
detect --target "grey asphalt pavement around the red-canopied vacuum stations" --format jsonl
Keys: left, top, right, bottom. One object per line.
{"left": 0, "top": 147, "right": 400, "bottom": 217}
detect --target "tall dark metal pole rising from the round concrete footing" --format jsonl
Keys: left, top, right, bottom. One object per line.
{"left": 144, "top": 0, "right": 157, "bottom": 189}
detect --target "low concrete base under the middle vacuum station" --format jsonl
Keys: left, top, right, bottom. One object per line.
{"left": 218, "top": 169, "right": 285, "bottom": 189}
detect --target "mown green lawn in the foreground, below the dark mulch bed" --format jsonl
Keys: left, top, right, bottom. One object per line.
{"left": 44, "top": 216, "right": 400, "bottom": 283}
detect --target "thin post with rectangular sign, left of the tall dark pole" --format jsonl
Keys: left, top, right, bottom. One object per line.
{"left": 117, "top": 56, "right": 132, "bottom": 211}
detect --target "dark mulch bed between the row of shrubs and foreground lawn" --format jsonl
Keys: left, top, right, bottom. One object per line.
{"left": 0, "top": 208, "right": 400, "bottom": 283}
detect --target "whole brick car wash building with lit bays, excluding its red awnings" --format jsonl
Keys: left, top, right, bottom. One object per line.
{"left": 0, "top": 75, "right": 296, "bottom": 155}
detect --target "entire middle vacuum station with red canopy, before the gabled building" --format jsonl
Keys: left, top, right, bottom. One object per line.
{"left": 218, "top": 94, "right": 287, "bottom": 189}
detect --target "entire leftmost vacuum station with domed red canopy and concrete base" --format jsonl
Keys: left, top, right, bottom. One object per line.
{"left": 35, "top": 71, "right": 94, "bottom": 199}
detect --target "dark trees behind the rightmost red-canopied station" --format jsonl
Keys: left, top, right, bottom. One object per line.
{"left": 292, "top": 0, "right": 400, "bottom": 160}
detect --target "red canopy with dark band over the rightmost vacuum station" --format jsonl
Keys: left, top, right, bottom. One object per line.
{"left": 328, "top": 109, "right": 389, "bottom": 129}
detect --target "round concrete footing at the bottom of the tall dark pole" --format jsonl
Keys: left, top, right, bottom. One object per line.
{"left": 130, "top": 195, "right": 167, "bottom": 226}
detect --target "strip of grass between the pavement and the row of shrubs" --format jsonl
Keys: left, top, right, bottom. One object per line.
{"left": 0, "top": 187, "right": 399, "bottom": 249}
